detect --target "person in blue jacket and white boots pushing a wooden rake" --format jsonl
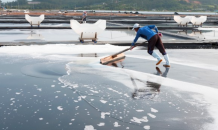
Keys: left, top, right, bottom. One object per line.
{"left": 131, "top": 23, "right": 170, "bottom": 67}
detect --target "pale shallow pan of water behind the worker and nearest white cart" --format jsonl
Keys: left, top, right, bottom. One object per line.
{"left": 0, "top": 29, "right": 180, "bottom": 42}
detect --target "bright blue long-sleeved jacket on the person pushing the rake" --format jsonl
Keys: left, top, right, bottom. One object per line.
{"left": 133, "top": 25, "right": 158, "bottom": 44}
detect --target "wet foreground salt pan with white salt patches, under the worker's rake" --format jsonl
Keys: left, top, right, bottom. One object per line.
{"left": 0, "top": 45, "right": 218, "bottom": 130}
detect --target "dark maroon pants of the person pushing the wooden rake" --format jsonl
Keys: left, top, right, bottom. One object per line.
{"left": 148, "top": 34, "right": 167, "bottom": 55}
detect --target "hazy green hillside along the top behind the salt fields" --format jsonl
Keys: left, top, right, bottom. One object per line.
{"left": 2, "top": 0, "right": 218, "bottom": 11}
